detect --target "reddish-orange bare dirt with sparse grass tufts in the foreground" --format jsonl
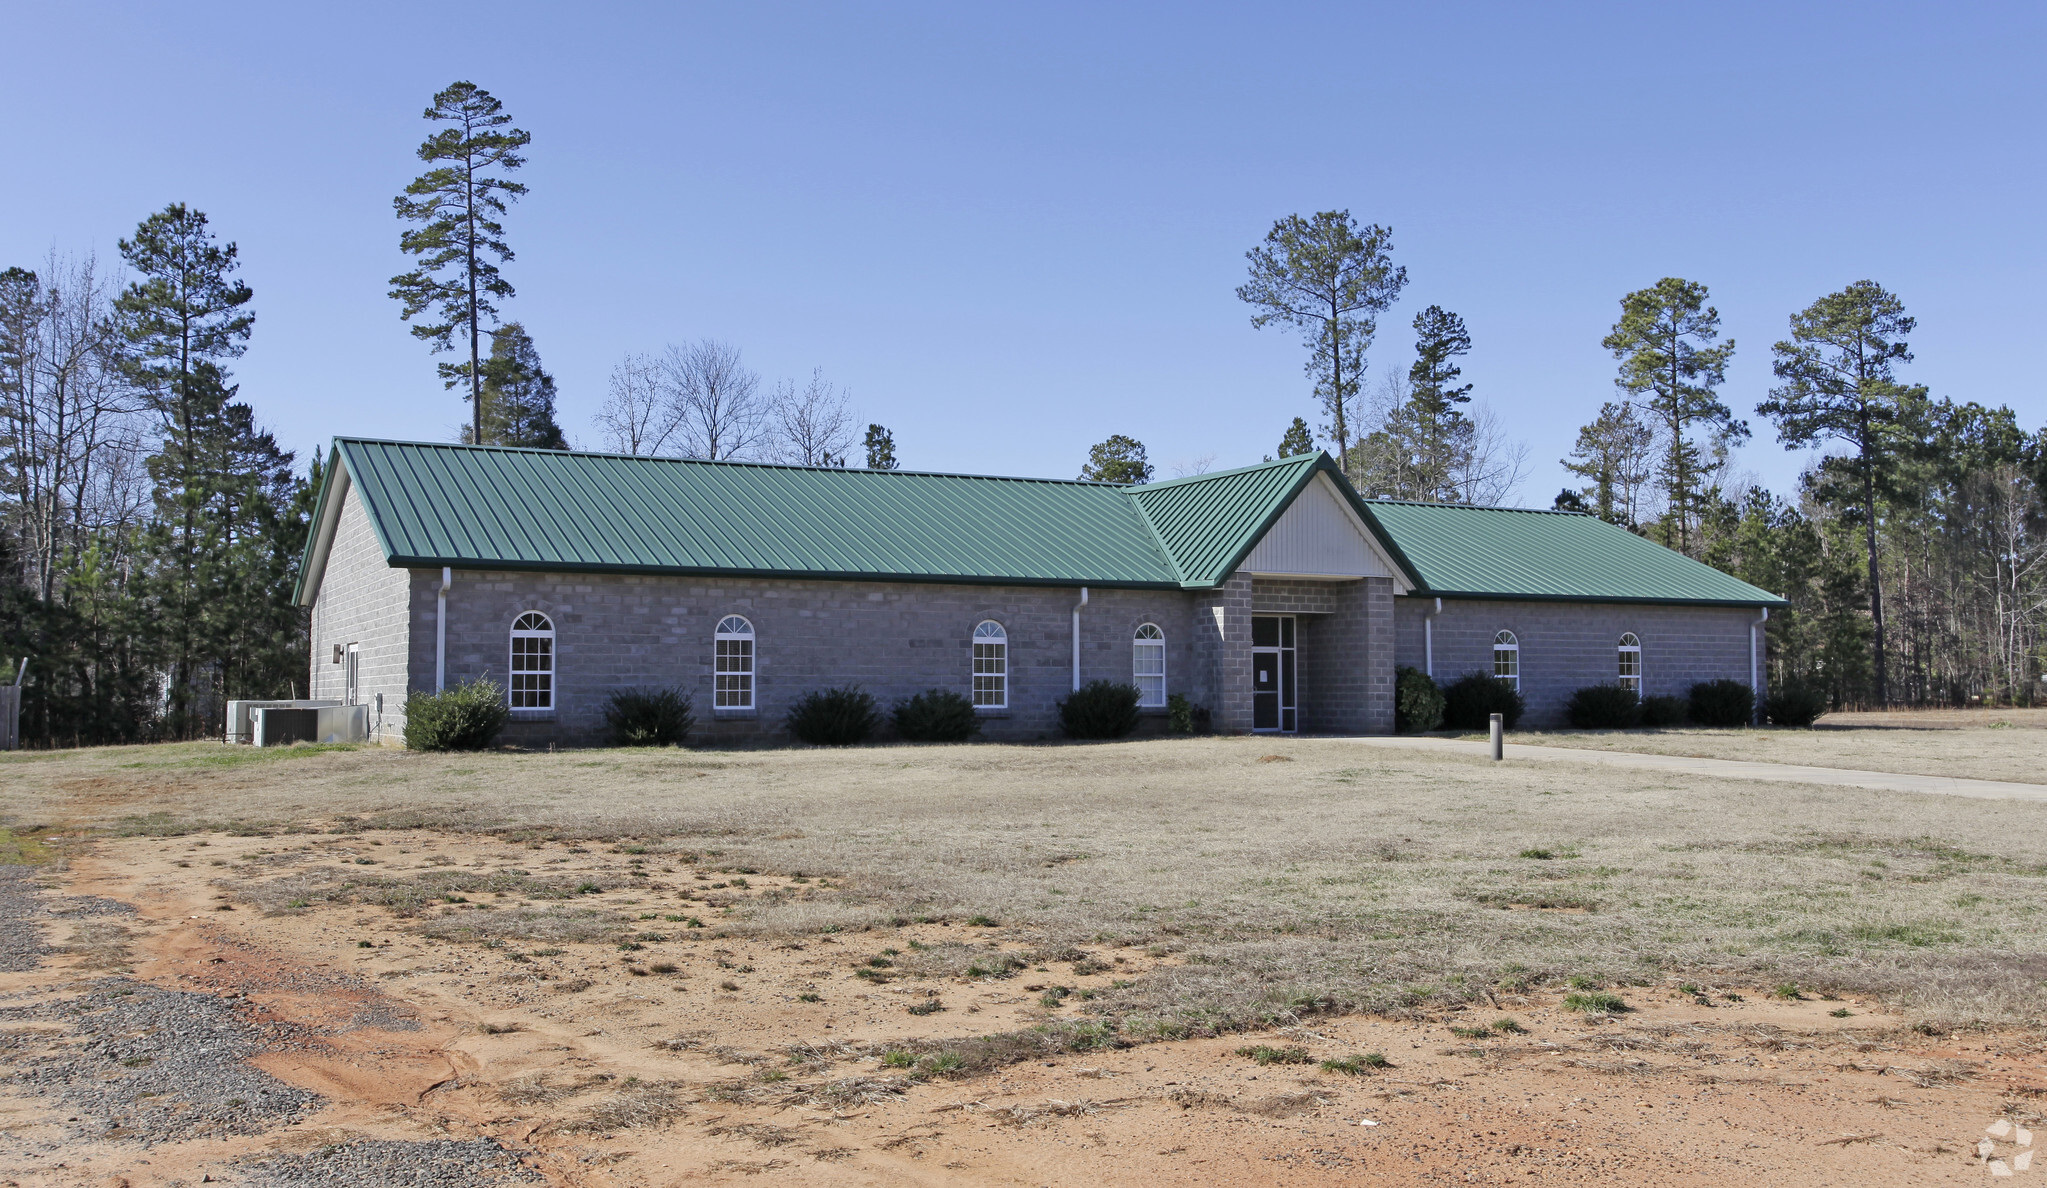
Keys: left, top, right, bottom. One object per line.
{"left": 0, "top": 832, "right": 2047, "bottom": 1188}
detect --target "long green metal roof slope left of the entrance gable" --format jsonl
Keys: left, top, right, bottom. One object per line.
{"left": 319, "top": 438, "right": 1179, "bottom": 586}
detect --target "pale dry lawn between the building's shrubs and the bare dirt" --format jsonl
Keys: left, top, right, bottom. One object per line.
{"left": 0, "top": 729, "right": 2047, "bottom": 1034}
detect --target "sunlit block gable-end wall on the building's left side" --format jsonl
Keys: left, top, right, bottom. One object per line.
{"left": 307, "top": 487, "right": 413, "bottom": 744}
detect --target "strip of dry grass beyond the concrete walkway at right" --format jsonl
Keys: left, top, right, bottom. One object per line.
{"left": 1522, "top": 709, "right": 2047, "bottom": 784}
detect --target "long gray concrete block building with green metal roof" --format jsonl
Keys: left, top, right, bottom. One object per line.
{"left": 299, "top": 438, "right": 1781, "bottom": 746}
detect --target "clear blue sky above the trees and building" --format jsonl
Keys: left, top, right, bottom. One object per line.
{"left": 0, "top": 4, "right": 2047, "bottom": 506}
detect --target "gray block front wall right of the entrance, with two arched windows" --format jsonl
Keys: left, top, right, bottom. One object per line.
{"left": 1394, "top": 598, "right": 1765, "bottom": 727}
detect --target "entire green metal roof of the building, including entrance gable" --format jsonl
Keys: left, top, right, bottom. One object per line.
{"left": 299, "top": 438, "right": 1777, "bottom": 604}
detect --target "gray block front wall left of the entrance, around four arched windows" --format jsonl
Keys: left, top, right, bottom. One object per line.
{"left": 411, "top": 569, "right": 1211, "bottom": 746}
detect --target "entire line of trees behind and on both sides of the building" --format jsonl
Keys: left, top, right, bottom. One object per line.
{"left": 0, "top": 82, "right": 2047, "bottom": 746}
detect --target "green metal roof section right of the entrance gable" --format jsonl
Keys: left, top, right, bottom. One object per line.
{"left": 1365, "top": 500, "right": 1785, "bottom": 606}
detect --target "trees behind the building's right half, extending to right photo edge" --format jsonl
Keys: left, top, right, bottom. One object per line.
{"left": 1162, "top": 211, "right": 2047, "bottom": 707}
